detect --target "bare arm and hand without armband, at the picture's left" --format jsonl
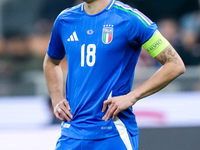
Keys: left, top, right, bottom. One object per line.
{"left": 43, "top": 54, "right": 72, "bottom": 121}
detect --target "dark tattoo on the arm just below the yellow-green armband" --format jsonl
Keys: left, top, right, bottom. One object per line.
{"left": 160, "top": 47, "right": 178, "bottom": 64}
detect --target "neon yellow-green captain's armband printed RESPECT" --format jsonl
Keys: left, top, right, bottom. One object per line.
{"left": 142, "top": 31, "right": 169, "bottom": 57}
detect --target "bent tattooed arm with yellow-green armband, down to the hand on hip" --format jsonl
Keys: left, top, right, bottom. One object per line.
{"left": 102, "top": 33, "right": 185, "bottom": 121}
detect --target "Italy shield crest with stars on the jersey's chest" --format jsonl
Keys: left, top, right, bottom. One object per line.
{"left": 102, "top": 25, "right": 113, "bottom": 44}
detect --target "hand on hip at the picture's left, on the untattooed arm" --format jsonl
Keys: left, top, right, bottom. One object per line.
{"left": 54, "top": 99, "right": 73, "bottom": 121}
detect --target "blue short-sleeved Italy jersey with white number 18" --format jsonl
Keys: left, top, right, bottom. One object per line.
{"left": 47, "top": 0, "right": 157, "bottom": 139}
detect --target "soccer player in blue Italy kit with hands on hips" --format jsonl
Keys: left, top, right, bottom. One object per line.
{"left": 44, "top": 0, "right": 185, "bottom": 150}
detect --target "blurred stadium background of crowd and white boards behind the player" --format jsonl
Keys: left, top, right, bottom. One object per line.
{"left": 0, "top": 0, "right": 200, "bottom": 150}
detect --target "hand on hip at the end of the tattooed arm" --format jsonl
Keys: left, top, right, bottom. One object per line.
{"left": 102, "top": 95, "right": 136, "bottom": 121}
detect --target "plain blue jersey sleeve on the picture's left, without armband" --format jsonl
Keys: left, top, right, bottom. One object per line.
{"left": 47, "top": 17, "right": 65, "bottom": 60}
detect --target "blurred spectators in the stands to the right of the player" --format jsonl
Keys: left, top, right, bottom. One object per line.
{"left": 140, "top": 10, "right": 200, "bottom": 66}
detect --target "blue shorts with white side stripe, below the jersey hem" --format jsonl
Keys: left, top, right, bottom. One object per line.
{"left": 55, "top": 133, "right": 139, "bottom": 150}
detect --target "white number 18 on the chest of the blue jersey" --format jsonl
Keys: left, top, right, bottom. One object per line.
{"left": 81, "top": 44, "right": 96, "bottom": 67}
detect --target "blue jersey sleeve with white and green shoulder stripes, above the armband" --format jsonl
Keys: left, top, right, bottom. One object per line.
{"left": 127, "top": 9, "right": 158, "bottom": 46}
